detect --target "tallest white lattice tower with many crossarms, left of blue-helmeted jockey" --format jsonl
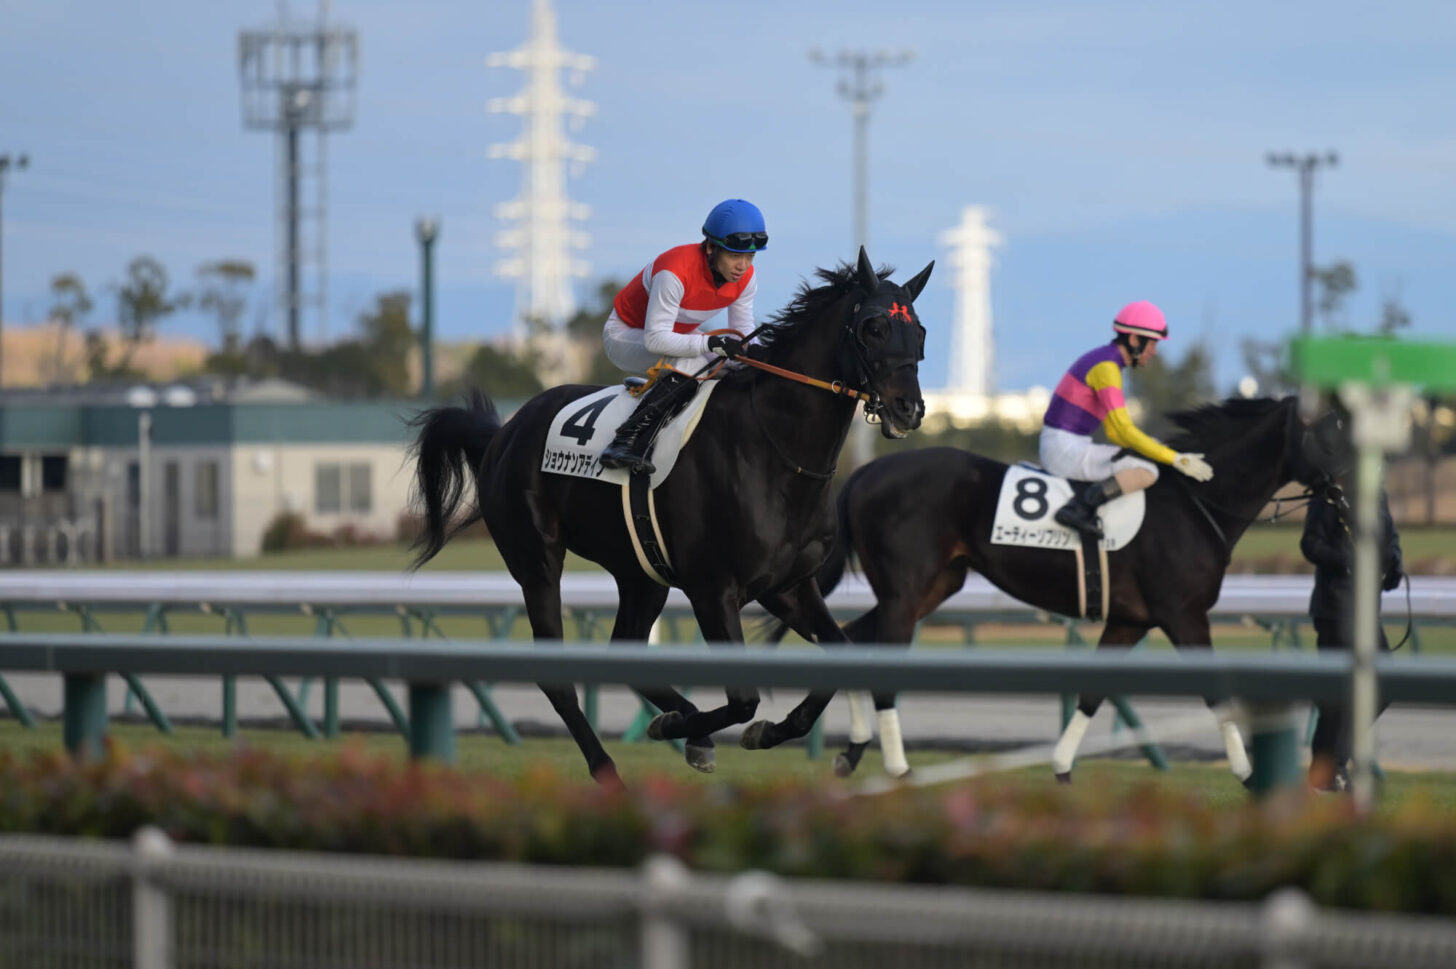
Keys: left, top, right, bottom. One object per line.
{"left": 485, "top": 0, "right": 597, "bottom": 339}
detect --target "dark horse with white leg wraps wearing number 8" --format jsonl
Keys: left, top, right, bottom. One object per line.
{"left": 773, "top": 397, "right": 1342, "bottom": 780}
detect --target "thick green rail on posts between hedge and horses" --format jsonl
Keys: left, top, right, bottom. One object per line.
{"left": 8, "top": 633, "right": 1456, "bottom": 789}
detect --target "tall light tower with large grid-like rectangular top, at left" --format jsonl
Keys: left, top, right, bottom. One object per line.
{"left": 237, "top": 0, "right": 358, "bottom": 349}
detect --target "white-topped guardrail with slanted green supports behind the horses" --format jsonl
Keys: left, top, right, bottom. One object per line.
{"left": 0, "top": 570, "right": 1456, "bottom": 765}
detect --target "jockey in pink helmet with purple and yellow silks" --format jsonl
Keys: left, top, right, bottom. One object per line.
{"left": 1041, "top": 300, "right": 1213, "bottom": 538}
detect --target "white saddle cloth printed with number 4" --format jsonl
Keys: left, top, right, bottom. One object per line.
{"left": 542, "top": 380, "right": 718, "bottom": 489}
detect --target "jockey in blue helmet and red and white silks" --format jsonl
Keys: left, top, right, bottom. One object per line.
{"left": 600, "top": 198, "right": 769, "bottom": 474}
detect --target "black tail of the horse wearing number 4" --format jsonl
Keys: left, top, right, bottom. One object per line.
{"left": 409, "top": 390, "right": 501, "bottom": 569}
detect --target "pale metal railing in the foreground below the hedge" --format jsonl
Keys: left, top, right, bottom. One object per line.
{"left": 0, "top": 828, "right": 1456, "bottom": 969}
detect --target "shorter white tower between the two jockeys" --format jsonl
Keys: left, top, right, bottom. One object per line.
{"left": 941, "top": 205, "right": 1002, "bottom": 397}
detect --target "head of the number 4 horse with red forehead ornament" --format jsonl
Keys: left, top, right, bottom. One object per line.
{"left": 843, "top": 246, "right": 935, "bottom": 438}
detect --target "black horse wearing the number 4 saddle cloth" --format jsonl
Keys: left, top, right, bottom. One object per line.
{"left": 415, "top": 249, "right": 935, "bottom": 784}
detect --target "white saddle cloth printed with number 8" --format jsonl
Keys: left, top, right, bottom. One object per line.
{"left": 992, "top": 464, "right": 1147, "bottom": 551}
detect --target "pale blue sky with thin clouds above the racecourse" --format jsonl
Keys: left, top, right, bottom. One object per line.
{"left": 0, "top": 0, "right": 1456, "bottom": 388}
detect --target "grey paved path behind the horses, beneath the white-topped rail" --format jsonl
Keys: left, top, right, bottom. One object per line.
{"left": 6, "top": 674, "right": 1456, "bottom": 770}
